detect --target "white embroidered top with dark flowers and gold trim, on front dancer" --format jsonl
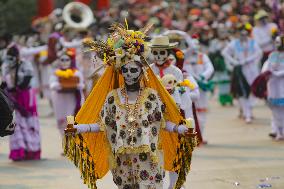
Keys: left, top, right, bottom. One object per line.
{"left": 101, "top": 88, "right": 165, "bottom": 163}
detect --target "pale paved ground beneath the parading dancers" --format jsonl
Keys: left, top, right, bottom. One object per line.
{"left": 0, "top": 97, "right": 284, "bottom": 189}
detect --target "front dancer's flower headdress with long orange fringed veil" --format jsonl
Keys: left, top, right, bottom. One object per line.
{"left": 64, "top": 24, "right": 194, "bottom": 189}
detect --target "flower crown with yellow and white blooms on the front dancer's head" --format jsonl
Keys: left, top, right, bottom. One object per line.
{"left": 83, "top": 23, "right": 152, "bottom": 69}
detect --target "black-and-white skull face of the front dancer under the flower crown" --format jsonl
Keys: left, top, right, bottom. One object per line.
{"left": 121, "top": 61, "right": 142, "bottom": 86}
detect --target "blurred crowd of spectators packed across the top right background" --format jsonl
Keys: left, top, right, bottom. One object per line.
{"left": 92, "top": 0, "right": 284, "bottom": 46}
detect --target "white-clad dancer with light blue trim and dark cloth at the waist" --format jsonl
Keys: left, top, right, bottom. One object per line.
{"left": 222, "top": 24, "right": 262, "bottom": 123}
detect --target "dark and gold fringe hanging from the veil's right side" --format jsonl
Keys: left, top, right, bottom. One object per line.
{"left": 174, "top": 136, "right": 197, "bottom": 189}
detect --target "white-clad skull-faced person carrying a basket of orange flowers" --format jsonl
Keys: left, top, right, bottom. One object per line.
{"left": 49, "top": 49, "right": 84, "bottom": 136}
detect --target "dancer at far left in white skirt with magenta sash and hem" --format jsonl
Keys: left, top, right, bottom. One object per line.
{"left": 2, "top": 46, "right": 41, "bottom": 161}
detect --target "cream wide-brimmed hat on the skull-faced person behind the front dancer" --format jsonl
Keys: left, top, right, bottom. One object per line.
{"left": 149, "top": 36, "right": 178, "bottom": 49}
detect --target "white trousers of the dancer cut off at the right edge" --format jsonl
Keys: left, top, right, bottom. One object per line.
{"left": 271, "top": 106, "right": 284, "bottom": 137}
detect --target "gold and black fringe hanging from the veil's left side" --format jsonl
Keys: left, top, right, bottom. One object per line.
{"left": 63, "top": 134, "right": 97, "bottom": 189}
